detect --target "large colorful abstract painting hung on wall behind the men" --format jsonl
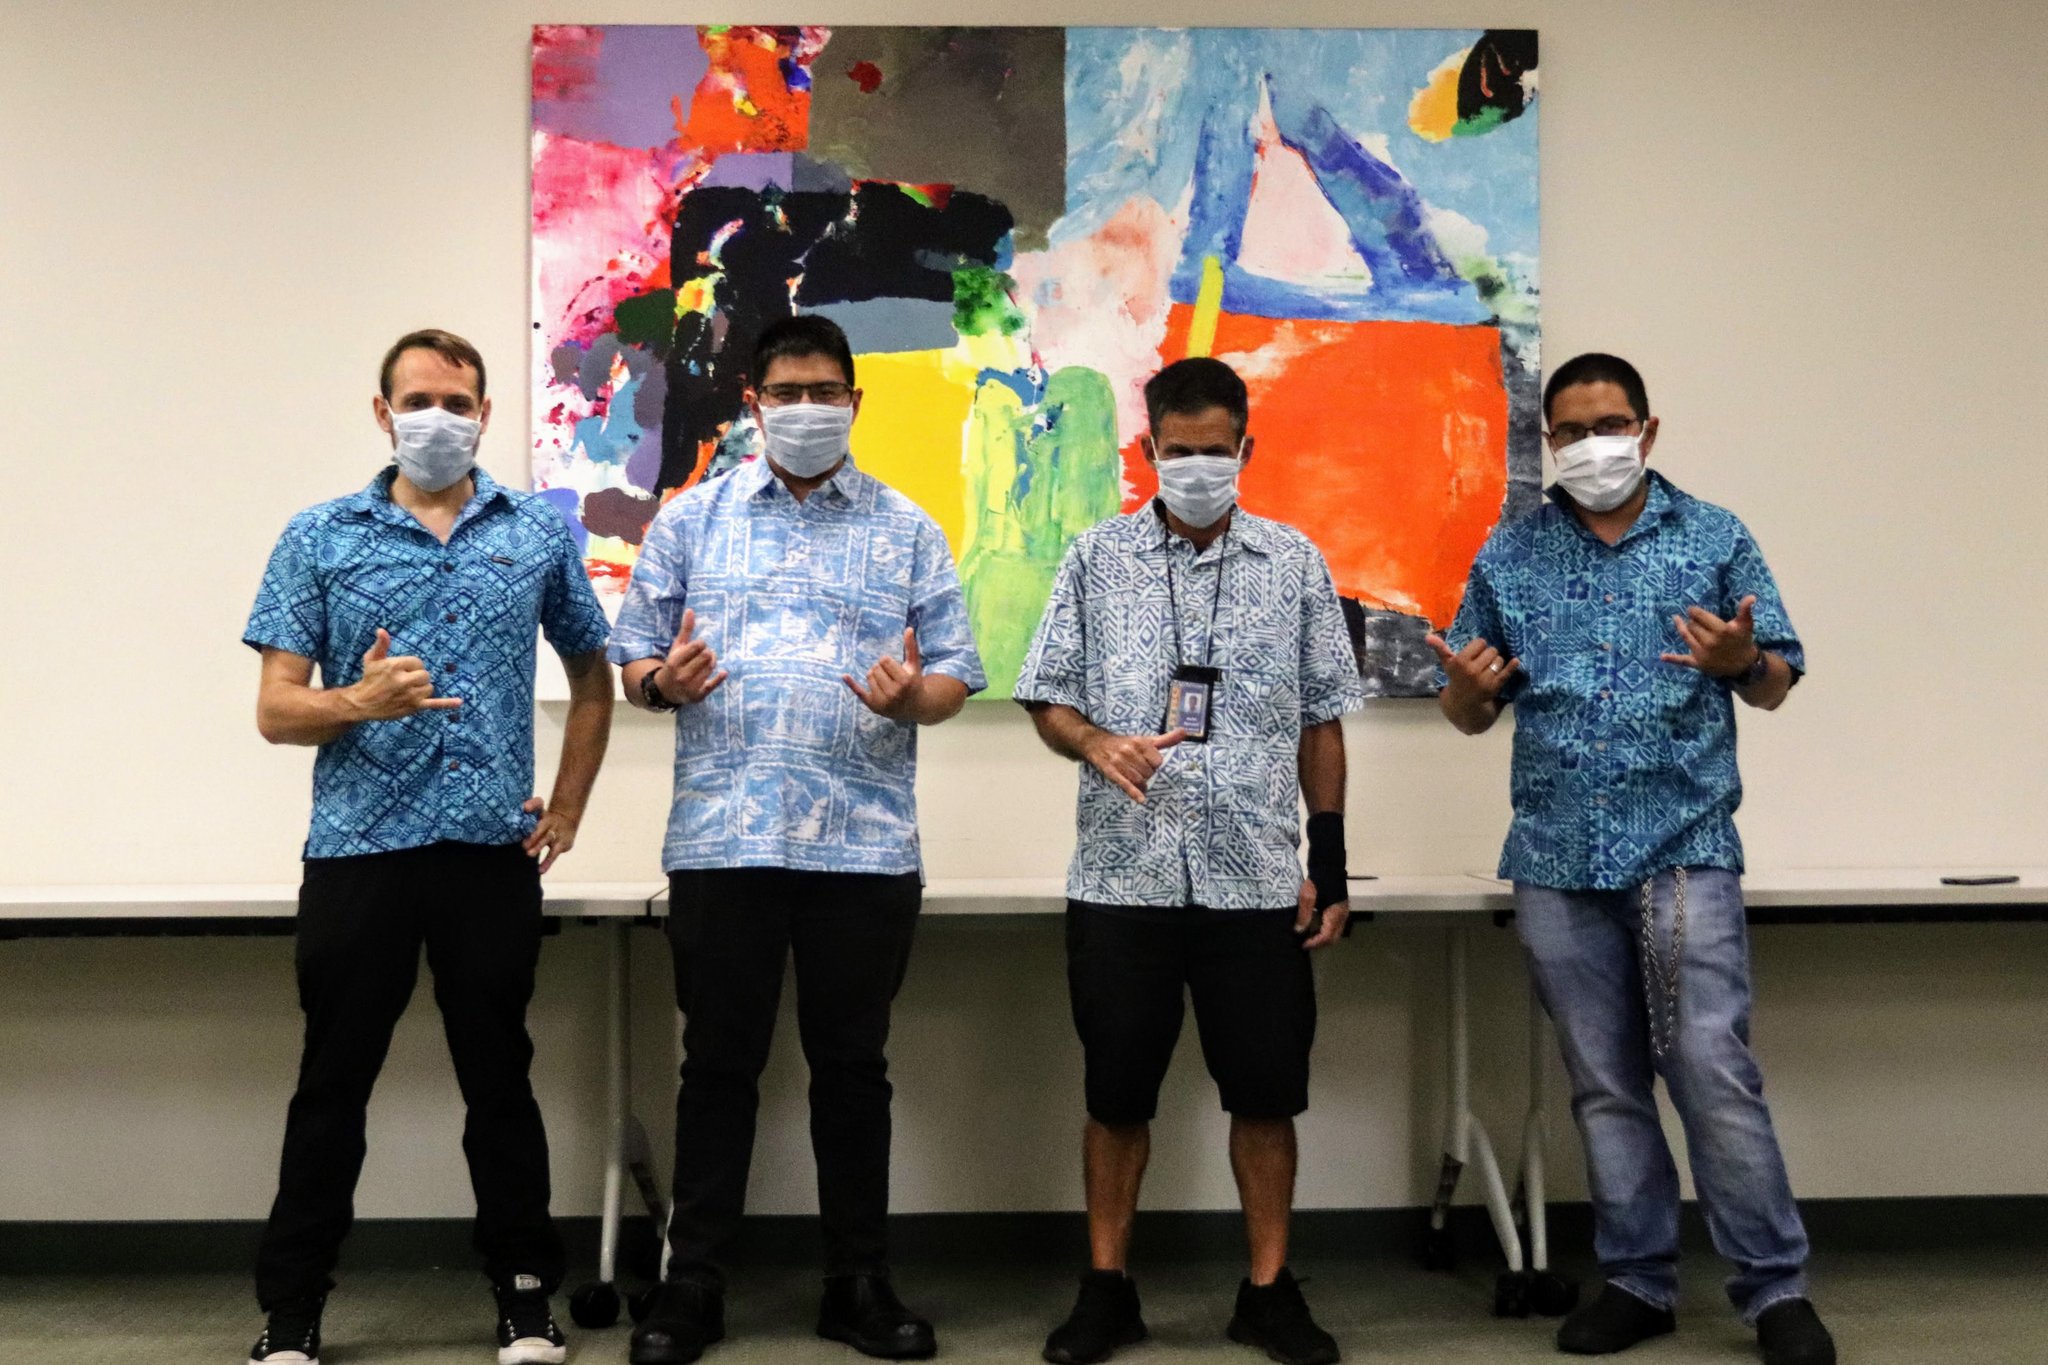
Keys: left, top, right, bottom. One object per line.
{"left": 532, "top": 25, "right": 1540, "bottom": 696}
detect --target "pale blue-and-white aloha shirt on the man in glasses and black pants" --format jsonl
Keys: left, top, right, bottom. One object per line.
{"left": 610, "top": 448, "right": 987, "bottom": 874}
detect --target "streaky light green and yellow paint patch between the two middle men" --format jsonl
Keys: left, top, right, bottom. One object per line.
{"left": 961, "top": 366, "right": 1122, "bottom": 698}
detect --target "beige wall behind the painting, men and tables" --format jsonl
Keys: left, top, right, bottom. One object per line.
{"left": 0, "top": 0, "right": 2048, "bottom": 1218}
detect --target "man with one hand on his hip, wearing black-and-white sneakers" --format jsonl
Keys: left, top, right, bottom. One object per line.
{"left": 244, "top": 332, "right": 612, "bottom": 1365}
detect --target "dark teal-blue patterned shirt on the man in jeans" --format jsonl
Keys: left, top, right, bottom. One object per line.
{"left": 1438, "top": 471, "right": 1806, "bottom": 890}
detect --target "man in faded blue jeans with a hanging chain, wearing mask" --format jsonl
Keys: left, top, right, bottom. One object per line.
{"left": 1430, "top": 354, "right": 1835, "bottom": 1365}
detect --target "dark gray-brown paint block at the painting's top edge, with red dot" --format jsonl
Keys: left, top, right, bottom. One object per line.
{"left": 811, "top": 27, "right": 1067, "bottom": 250}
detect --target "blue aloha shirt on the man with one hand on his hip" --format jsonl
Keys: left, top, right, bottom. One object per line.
{"left": 242, "top": 465, "right": 606, "bottom": 857}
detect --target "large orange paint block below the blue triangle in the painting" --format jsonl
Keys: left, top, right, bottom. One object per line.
{"left": 1124, "top": 303, "right": 1507, "bottom": 630}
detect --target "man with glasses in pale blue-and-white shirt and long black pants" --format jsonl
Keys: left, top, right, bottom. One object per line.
{"left": 610, "top": 315, "right": 987, "bottom": 1365}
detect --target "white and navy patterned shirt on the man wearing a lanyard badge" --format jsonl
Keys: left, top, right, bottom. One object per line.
{"left": 1016, "top": 501, "right": 1364, "bottom": 911}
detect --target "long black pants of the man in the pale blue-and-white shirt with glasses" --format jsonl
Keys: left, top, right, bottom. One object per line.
{"left": 668, "top": 868, "right": 924, "bottom": 1289}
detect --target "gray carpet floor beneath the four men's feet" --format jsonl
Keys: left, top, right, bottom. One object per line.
{"left": 0, "top": 1250, "right": 2048, "bottom": 1365}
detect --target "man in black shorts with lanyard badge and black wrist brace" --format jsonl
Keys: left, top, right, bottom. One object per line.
{"left": 1016, "top": 358, "right": 1364, "bottom": 1365}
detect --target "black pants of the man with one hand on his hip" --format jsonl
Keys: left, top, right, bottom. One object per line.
{"left": 256, "top": 843, "right": 563, "bottom": 1312}
